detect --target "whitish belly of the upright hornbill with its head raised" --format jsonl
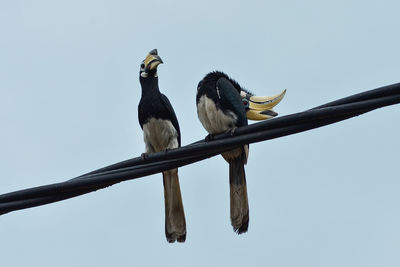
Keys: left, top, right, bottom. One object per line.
{"left": 143, "top": 118, "right": 179, "bottom": 153}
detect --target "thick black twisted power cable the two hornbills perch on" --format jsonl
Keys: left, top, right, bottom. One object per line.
{"left": 0, "top": 83, "right": 400, "bottom": 214}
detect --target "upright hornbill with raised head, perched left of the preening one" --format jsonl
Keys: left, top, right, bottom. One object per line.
{"left": 138, "top": 49, "right": 186, "bottom": 243}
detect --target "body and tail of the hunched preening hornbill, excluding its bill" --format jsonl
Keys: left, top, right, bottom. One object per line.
{"left": 196, "top": 72, "right": 249, "bottom": 234}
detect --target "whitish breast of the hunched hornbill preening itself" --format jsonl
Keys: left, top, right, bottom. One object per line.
{"left": 197, "top": 95, "right": 237, "bottom": 134}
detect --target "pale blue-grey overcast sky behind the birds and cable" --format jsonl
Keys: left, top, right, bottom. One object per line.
{"left": 0, "top": 0, "right": 400, "bottom": 267}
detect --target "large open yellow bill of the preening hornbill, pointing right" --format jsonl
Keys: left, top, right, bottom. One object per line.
{"left": 240, "top": 89, "right": 286, "bottom": 121}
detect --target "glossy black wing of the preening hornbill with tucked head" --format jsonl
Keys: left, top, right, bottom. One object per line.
{"left": 217, "top": 78, "right": 248, "bottom": 126}
